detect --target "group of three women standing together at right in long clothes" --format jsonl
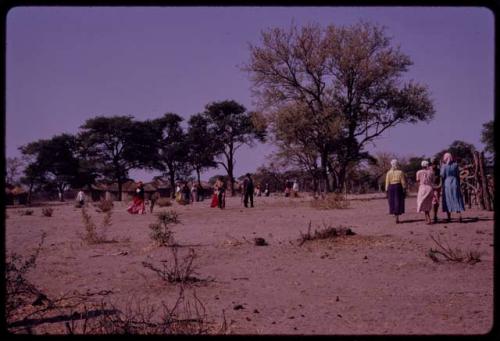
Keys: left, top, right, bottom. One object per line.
{"left": 385, "top": 153, "right": 465, "bottom": 225}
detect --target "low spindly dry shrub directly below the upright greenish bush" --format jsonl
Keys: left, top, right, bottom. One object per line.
{"left": 142, "top": 246, "right": 208, "bottom": 285}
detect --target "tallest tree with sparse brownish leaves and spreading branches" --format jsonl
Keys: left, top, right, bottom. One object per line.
{"left": 243, "top": 22, "right": 434, "bottom": 188}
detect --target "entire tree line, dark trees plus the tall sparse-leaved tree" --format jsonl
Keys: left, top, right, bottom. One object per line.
{"left": 5, "top": 22, "right": 493, "bottom": 199}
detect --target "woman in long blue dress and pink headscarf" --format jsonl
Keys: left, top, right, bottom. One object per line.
{"left": 440, "top": 153, "right": 465, "bottom": 222}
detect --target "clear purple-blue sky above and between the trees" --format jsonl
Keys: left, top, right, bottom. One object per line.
{"left": 5, "top": 7, "right": 494, "bottom": 181}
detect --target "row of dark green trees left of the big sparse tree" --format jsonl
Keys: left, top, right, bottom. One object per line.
{"left": 11, "top": 101, "right": 265, "bottom": 200}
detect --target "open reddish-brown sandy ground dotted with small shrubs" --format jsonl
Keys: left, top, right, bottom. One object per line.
{"left": 6, "top": 195, "right": 494, "bottom": 335}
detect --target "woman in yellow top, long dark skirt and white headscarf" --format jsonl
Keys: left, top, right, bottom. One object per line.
{"left": 385, "top": 159, "right": 406, "bottom": 224}
